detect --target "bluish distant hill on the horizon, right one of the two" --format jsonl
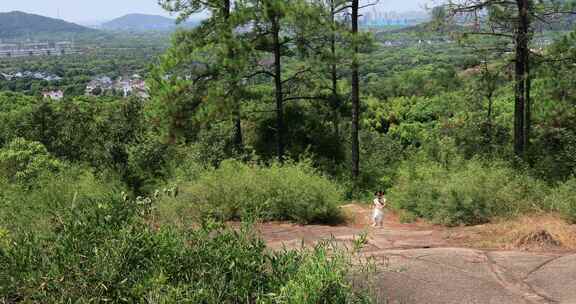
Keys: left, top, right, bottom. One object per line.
{"left": 102, "top": 14, "right": 196, "bottom": 31}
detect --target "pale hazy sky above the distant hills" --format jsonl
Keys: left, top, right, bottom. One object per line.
{"left": 0, "top": 0, "right": 429, "bottom": 22}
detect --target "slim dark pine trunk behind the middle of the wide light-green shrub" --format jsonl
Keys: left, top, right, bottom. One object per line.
{"left": 272, "top": 17, "right": 285, "bottom": 162}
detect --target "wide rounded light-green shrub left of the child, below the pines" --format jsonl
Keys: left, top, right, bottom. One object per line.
{"left": 159, "top": 160, "right": 342, "bottom": 223}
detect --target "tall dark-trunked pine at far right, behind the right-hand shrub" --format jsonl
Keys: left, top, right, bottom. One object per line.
{"left": 445, "top": 0, "right": 574, "bottom": 158}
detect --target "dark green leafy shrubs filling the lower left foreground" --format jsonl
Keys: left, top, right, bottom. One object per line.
{"left": 0, "top": 195, "right": 363, "bottom": 304}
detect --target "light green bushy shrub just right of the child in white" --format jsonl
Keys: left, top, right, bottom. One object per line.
{"left": 389, "top": 151, "right": 549, "bottom": 226}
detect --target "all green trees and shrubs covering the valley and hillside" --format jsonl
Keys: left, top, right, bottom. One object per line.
{"left": 0, "top": 0, "right": 576, "bottom": 303}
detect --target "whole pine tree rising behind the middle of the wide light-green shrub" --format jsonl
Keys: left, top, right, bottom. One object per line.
{"left": 238, "top": 0, "right": 321, "bottom": 161}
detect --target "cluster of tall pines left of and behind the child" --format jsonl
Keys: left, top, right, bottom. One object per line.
{"left": 152, "top": 0, "right": 380, "bottom": 185}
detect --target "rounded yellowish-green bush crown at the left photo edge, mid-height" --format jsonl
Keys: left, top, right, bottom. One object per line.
{"left": 0, "top": 138, "right": 63, "bottom": 185}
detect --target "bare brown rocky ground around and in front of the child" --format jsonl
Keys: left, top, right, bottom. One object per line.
{"left": 260, "top": 205, "right": 576, "bottom": 304}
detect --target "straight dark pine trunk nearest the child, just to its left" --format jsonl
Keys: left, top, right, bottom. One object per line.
{"left": 352, "top": 0, "right": 360, "bottom": 182}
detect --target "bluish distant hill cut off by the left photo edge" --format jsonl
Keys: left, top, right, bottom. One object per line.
{"left": 0, "top": 11, "right": 94, "bottom": 38}
